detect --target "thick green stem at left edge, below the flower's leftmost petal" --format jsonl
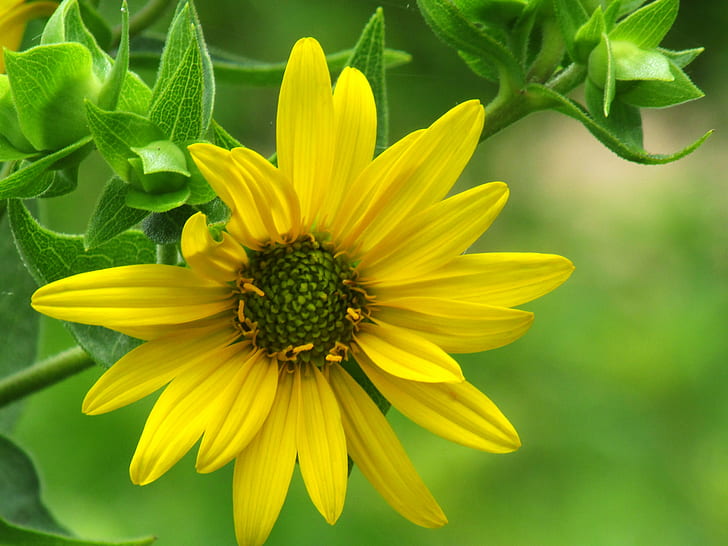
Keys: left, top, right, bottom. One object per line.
{"left": 0, "top": 347, "right": 94, "bottom": 407}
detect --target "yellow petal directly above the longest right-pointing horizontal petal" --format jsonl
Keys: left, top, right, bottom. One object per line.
{"left": 359, "top": 182, "right": 508, "bottom": 279}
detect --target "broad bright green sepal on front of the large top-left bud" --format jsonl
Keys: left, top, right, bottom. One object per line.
{"left": 5, "top": 43, "right": 101, "bottom": 150}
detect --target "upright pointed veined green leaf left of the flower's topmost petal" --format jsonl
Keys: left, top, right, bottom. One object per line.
{"left": 149, "top": 0, "right": 215, "bottom": 142}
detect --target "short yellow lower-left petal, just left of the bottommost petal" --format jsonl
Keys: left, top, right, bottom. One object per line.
{"left": 196, "top": 344, "right": 278, "bottom": 473}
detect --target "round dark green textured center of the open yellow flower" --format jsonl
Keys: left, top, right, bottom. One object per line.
{"left": 238, "top": 236, "right": 366, "bottom": 365}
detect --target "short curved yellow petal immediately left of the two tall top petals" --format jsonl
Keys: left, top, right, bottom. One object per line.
{"left": 231, "top": 148, "right": 302, "bottom": 241}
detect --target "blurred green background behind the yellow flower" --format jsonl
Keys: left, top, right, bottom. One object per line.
{"left": 7, "top": 0, "right": 728, "bottom": 546}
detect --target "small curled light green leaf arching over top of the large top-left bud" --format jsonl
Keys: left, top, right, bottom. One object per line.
{"left": 40, "top": 0, "right": 111, "bottom": 81}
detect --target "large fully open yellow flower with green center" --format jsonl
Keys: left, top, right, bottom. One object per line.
{"left": 33, "top": 38, "right": 573, "bottom": 544}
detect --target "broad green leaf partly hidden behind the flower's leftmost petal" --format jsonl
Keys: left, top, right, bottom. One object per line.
{"left": 8, "top": 200, "right": 156, "bottom": 367}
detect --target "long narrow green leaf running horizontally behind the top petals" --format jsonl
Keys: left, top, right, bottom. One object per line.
{"left": 130, "top": 36, "right": 412, "bottom": 87}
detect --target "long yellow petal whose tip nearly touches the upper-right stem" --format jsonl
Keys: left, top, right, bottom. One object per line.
{"left": 342, "top": 100, "right": 484, "bottom": 253}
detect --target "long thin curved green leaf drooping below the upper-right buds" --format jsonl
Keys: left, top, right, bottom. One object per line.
{"left": 525, "top": 84, "right": 713, "bottom": 165}
